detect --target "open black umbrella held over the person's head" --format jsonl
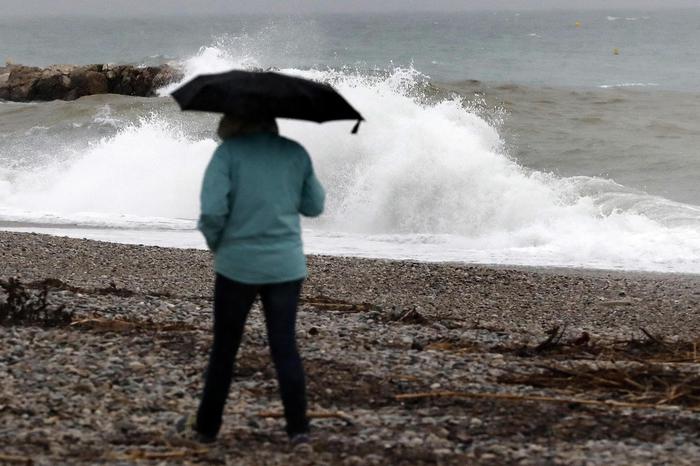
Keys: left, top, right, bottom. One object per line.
{"left": 172, "top": 70, "right": 364, "bottom": 133}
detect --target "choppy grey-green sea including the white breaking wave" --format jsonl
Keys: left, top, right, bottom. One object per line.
{"left": 0, "top": 12, "right": 700, "bottom": 273}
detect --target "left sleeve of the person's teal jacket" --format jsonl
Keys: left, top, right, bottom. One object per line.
{"left": 197, "top": 146, "right": 233, "bottom": 252}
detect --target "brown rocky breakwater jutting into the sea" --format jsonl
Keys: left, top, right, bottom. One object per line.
{"left": 0, "top": 64, "right": 182, "bottom": 102}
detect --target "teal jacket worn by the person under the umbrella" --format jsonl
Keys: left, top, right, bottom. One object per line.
{"left": 198, "top": 132, "right": 325, "bottom": 284}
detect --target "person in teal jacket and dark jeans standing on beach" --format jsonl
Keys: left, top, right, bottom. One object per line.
{"left": 176, "top": 116, "right": 325, "bottom": 446}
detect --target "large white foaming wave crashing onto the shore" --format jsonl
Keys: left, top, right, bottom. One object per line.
{"left": 0, "top": 45, "right": 700, "bottom": 273}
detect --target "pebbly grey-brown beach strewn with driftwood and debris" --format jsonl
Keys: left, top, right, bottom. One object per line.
{"left": 0, "top": 232, "right": 700, "bottom": 465}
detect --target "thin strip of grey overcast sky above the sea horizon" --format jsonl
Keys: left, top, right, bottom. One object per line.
{"left": 0, "top": 0, "right": 700, "bottom": 18}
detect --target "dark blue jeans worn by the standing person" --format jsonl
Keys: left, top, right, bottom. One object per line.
{"left": 197, "top": 274, "right": 309, "bottom": 436}
